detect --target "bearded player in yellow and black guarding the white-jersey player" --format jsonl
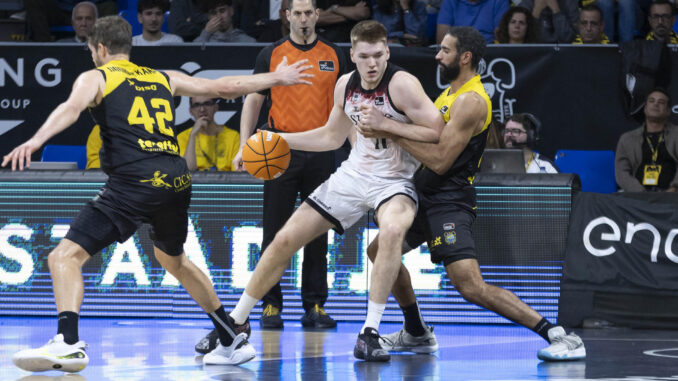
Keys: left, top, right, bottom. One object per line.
{"left": 360, "top": 27, "right": 586, "bottom": 361}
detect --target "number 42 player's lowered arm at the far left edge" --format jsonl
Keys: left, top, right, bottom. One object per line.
{"left": 2, "top": 70, "right": 105, "bottom": 171}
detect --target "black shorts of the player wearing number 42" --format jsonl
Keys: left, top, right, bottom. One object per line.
{"left": 66, "top": 157, "right": 191, "bottom": 256}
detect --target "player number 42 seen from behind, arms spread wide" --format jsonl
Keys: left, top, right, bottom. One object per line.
{"left": 2, "top": 16, "right": 312, "bottom": 372}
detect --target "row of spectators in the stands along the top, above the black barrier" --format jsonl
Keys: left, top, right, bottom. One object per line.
{"left": 12, "top": 0, "right": 678, "bottom": 46}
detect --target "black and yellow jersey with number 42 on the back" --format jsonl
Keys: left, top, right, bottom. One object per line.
{"left": 90, "top": 60, "right": 179, "bottom": 173}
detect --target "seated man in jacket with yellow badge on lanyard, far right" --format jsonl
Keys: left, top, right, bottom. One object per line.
{"left": 614, "top": 88, "right": 678, "bottom": 192}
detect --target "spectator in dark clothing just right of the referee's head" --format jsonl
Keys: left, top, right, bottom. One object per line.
{"left": 316, "top": 0, "right": 370, "bottom": 42}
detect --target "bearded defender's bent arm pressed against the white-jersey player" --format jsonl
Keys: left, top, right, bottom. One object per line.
{"left": 395, "top": 92, "right": 487, "bottom": 174}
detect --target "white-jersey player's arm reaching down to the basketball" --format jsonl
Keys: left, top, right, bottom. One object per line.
{"left": 280, "top": 75, "right": 353, "bottom": 152}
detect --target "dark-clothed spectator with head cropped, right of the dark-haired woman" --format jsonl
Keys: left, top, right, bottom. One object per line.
{"left": 513, "top": 0, "right": 579, "bottom": 44}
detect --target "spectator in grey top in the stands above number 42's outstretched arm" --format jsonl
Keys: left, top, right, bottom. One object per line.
{"left": 198, "top": 0, "right": 257, "bottom": 42}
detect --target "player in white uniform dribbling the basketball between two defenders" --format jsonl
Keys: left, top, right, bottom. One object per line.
{"left": 229, "top": 20, "right": 444, "bottom": 361}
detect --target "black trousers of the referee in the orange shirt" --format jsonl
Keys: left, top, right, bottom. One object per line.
{"left": 261, "top": 150, "right": 334, "bottom": 311}
